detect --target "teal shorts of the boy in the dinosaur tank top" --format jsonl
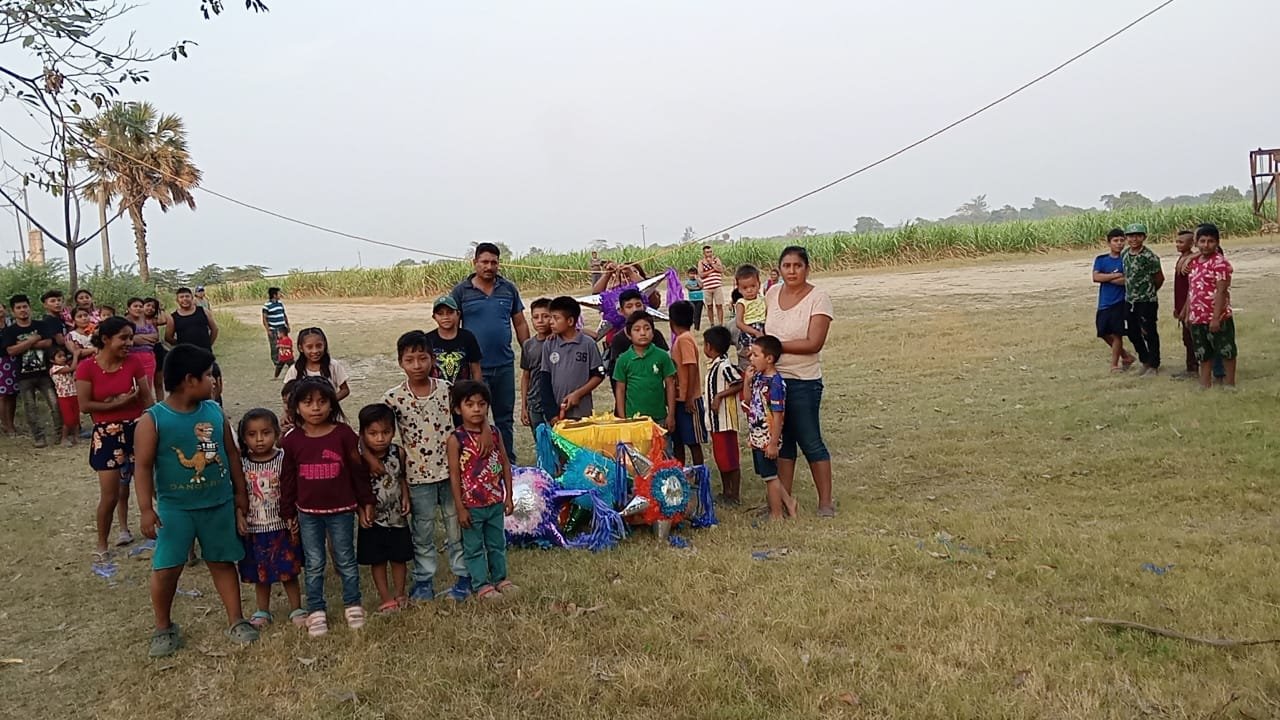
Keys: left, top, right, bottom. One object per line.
{"left": 151, "top": 500, "right": 244, "bottom": 570}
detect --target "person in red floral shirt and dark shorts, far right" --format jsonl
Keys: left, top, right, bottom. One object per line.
{"left": 1183, "top": 223, "right": 1236, "bottom": 388}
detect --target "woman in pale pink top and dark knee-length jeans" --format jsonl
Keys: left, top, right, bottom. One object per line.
{"left": 764, "top": 245, "right": 836, "bottom": 518}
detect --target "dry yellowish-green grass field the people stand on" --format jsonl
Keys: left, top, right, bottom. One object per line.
{"left": 0, "top": 241, "right": 1280, "bottom": 719}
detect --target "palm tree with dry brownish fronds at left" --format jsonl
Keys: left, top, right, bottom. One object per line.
{"left": 76, "top": 102, "right": 201, "bottom": 282}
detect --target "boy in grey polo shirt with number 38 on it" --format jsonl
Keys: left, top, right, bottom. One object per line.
{"left": 541, "top": 295, "right": 604, "bottom": 420}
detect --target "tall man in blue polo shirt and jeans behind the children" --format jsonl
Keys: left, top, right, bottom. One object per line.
{"left": 452, "top": 242, "right": 529, "bottom": 465}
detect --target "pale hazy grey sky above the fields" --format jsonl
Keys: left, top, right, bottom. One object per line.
{"left": 0, "top": 0, "right": 1280, "bottom": 272}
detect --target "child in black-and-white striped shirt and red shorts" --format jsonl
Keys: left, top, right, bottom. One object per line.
{"left": 703, "top": 325, "right": 742, "bottom": 506}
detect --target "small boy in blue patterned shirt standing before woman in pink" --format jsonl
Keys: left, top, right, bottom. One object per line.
{"left": 742, "top": 336, "right": 796, "bottom": 520}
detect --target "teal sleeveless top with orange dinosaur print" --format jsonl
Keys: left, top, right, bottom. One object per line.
{"left": 147, "top": 400, "right": 233, "bottom": 510}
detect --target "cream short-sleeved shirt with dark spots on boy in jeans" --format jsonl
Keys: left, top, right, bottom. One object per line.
{"left": 383, "top": 379, "right": 453, "bottom": 486}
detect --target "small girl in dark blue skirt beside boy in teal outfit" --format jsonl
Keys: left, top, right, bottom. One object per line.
{"left": 236, "top": 407, "right": 307, "bottom": 629}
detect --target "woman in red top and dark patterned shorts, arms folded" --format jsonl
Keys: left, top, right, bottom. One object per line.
{"left": 76, "top": 318, "right": 154, "bottom": 562}
